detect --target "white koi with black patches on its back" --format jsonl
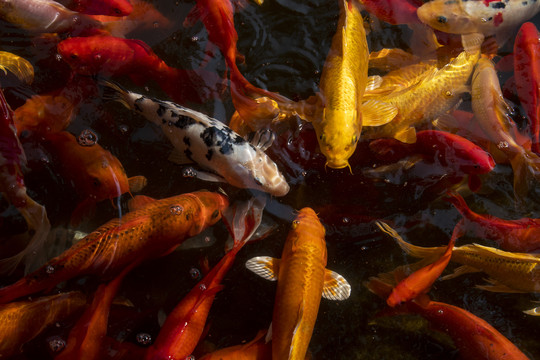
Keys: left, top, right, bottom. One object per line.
{"left": 99, "top": 83, "right": 289, "bottom": 196}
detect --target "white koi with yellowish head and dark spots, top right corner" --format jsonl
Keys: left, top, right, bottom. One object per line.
{"left": 417, "top": 0, "right": 540, "bottom": 36}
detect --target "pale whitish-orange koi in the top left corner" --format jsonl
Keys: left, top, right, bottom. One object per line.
{"left": 0, "top": 0, "right": 102, "bottom": 35}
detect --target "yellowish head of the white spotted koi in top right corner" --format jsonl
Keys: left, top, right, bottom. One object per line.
{"left": 417, "top": 0, "right": 478, "bottom": 34}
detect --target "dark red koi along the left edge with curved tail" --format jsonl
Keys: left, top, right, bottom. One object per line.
{"left": 0, "top": 90, "right": 51, "bottom": 272}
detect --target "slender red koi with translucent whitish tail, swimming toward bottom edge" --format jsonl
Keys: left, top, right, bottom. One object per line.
{"left": 145, "top": 199, "right": 266, "bottom": 360}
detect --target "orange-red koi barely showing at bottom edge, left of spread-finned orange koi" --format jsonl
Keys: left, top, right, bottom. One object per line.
{"left": 201, "top": 330, "right": 272, "bottom": 360}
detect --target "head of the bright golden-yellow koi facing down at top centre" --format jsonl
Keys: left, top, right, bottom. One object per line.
{"left": 314, "top": 108, "right": 361, "bottom": 169}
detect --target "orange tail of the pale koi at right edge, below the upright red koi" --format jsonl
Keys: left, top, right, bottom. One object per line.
{"left": 510, "top": 150, "right": 540, "bottom": 201}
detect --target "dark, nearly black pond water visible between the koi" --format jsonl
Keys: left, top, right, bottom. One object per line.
{"left": 0, "top": 0, "right": 540, "bottom": 359}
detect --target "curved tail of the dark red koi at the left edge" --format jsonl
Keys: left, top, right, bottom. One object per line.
{"left": 0, "top": 195, "right": 51, "bottom": 274}
